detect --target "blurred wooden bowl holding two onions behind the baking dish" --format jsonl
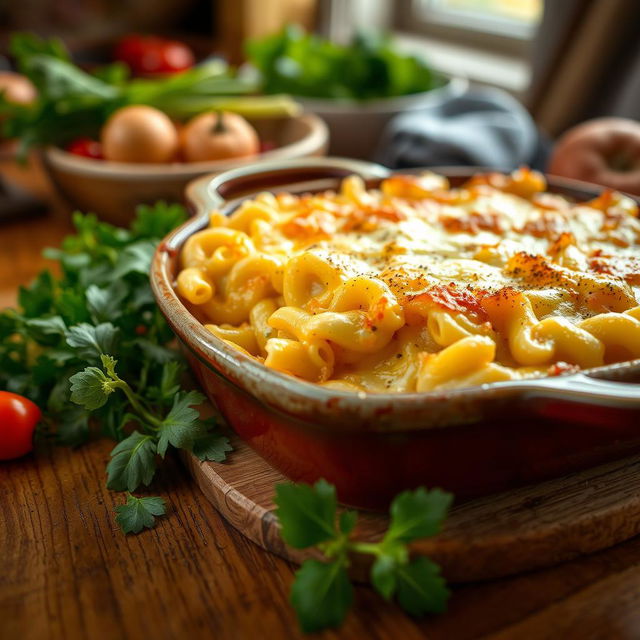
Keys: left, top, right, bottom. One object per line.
{"left": 43, "top": 113, "right": 329, "bottom": 226}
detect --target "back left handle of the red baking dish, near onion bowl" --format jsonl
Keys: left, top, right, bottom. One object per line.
{"left": 206, "top": 158, "right": 390, "bottom": 209}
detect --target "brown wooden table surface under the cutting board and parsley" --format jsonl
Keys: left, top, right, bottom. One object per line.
{"left": 0, "top": 156, "right": 640, "bottom": 640}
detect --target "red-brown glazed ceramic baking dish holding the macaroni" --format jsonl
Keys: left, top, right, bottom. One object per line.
{"left": 151, "top": 158, "right": 640, "bottom": 507}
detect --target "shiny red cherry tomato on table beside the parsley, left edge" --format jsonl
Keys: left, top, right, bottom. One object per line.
{"left": 0, "top": 391, "right": 42, "bottom": 460}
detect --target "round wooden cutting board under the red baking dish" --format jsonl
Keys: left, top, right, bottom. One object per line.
{"left": 185, "top": 436, "right": 640, "bottom": 582}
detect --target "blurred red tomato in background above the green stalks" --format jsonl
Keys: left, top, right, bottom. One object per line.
{"left": 115, "top": 35, "right": 195, "bottom": 75}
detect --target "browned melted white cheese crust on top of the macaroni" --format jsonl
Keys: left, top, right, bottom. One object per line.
{"left": 266, "top": 175, "right": 640, "bottom": 317}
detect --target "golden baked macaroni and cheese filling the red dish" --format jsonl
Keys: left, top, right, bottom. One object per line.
{"left": 176, "top": 169, "right": 640, "bottom": 392}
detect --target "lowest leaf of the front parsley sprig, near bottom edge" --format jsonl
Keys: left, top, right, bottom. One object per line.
{"left": 291, "top": 559, "right": 353, "bottom": 633}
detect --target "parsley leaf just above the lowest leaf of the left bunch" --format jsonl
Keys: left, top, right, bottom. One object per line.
{"left": 107, "top": 431, "right": 156, "bottom": 491}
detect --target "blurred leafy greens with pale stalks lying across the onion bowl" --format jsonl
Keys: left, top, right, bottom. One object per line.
{"left": 0, "top": 33, "right": 297, "bottom": 158}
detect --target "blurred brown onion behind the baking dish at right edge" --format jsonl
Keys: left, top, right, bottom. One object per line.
{"left": 547, "top": 118, "right": 640, "bottom": 195}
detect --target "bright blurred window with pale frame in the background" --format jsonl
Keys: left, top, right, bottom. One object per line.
{"left": 319, "top": 0, "right": 552, "bottom": 98}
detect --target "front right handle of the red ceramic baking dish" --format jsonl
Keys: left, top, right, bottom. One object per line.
{"left": 526, "top": 373, "right": 640, "bottom": 410}
